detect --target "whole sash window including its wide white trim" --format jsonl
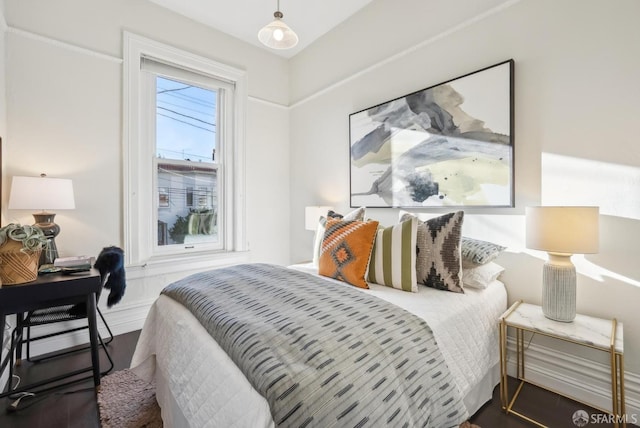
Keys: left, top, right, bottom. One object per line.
{"left": 125, "top": 33, "right": 246, "bottom": 264}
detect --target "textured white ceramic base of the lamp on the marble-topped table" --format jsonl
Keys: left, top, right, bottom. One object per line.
{"left": 542, "top": 253, "right": 576, "bottom": 322}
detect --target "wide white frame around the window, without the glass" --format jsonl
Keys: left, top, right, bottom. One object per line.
{"left": 123, "top": 31, "right": 248, "bottom": 266}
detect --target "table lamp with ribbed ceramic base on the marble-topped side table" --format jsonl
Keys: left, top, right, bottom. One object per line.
{"left": 526, "top": 207, "right": 599, "bottom": 322}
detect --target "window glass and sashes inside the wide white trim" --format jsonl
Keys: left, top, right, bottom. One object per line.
{"left": 141, "top": 65, "right": 224, "bottom": 252}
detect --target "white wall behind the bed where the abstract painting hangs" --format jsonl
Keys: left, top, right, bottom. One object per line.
{"left": 291, "top": 0, "right": 640, "bottom": 412}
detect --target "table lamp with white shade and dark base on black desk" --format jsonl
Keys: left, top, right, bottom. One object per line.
{"left": 8, "top": 174, "right": 76, "bottom": 265}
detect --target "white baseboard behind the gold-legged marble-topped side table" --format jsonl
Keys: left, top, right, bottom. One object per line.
{"left": 507, "top": 338, "right": 640, "bottom": 421}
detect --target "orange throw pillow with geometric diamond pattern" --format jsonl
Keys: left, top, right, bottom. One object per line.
{"left": 318, "top": 219, "right": 378, "bottom": 288}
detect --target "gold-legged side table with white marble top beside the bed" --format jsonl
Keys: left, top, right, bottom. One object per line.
{"left": 500, "top": 300, "right": 627, "bottom": 427}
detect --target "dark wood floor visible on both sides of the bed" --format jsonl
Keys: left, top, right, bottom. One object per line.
{"left": 0, "top": 331, "right": 630, "bottom": 428}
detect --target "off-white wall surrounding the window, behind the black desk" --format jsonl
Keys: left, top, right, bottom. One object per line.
{"left": 0, "top": 0, "right": 290, "bottom": 340}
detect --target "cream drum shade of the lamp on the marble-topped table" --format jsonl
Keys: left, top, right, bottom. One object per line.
{"left": 526, "top": 207, "right": 600, "bottom": 254}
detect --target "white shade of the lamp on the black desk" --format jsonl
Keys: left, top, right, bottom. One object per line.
{"left": 8, "top": 176, "right": 76, "bottom": 211}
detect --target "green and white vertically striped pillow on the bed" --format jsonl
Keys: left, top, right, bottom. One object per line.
{"left": 368, "top": 218, "right": 418, "bottom": 293}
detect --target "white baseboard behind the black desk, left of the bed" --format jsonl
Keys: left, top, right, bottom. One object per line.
{"left": 25, "top": 300, "right": 153, "bottom": 356}
